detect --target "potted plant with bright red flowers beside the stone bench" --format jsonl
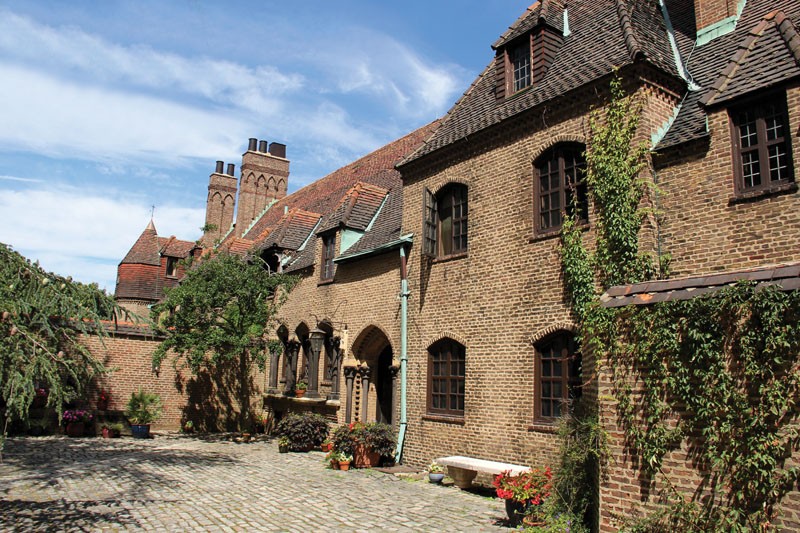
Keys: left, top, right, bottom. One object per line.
{"left": 492, "top": 466, "right": 553, "bottom": 527}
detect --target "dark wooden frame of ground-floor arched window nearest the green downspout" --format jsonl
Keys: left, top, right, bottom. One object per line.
{"left": 425, "top": 339, "right": 467, "bottom": 419}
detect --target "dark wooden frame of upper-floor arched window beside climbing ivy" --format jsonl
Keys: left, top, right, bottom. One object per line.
{"left": 533, "top": 143, "right": 589, "bottom": 235}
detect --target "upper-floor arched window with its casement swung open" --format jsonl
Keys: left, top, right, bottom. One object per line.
{"left": 423, "top": 183, "right": 469, "bottom": 257}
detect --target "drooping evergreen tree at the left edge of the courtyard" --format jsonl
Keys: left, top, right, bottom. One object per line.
{"left": 0, "top": 243, "right": 120, "bottom": 450}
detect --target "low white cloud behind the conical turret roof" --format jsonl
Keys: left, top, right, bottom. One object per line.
{"left": 0, "top": 188, "right": 205, "bottom": 292}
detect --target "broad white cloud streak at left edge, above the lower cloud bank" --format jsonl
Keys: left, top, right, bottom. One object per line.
{"left": 0, "top": 62, "right": 248, "bottom": 165}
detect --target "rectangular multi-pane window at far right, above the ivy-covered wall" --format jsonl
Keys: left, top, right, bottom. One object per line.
{"left": 730, "top": 94, "right": 794, "bottom": 193}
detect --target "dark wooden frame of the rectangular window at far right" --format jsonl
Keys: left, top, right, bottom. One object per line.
{"left": 728, "top": 91, "right": 794, "bottom": 196}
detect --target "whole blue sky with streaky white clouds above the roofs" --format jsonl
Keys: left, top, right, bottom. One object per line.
{"left": 0, "top": 0, "right": 528, "bottom": 292}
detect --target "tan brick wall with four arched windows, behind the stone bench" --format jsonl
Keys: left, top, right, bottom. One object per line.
{"left": 396, "top": 77, "right": 675, "bottom": 472}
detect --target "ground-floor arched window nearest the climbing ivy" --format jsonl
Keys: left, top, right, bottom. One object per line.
{"left": 535, "top": 332, "right": 582, "bottom": 419}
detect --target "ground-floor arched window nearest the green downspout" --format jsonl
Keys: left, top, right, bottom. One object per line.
{"left": 428, "top": 339, "right": 466, "bottom": 417}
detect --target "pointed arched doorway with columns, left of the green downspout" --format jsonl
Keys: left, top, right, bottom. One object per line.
{"left": 349, "top": 326, "right": 397, "bottom": 424}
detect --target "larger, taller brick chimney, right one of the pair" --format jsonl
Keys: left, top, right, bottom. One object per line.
{"left": 236, "top": 139, "right": 289, "bottom": 236}
